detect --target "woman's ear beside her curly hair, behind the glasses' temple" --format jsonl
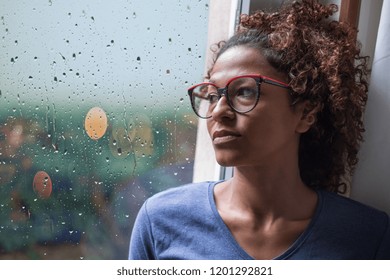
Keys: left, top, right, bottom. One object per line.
{"left": 295, "top": 100, "right": 320, "bottom": 133}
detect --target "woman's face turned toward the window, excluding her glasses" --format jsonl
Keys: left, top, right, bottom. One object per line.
{"left": 207, "top": 46, "right": 308, "bottom": 166}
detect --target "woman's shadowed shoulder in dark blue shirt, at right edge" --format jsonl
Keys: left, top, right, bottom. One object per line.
{"left": 284, "top": 190, "right": 390, "bottom": 259}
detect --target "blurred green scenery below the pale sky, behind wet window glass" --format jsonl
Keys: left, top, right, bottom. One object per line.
{"left": 0, "top": 103, "right": 196, "bottom": 259}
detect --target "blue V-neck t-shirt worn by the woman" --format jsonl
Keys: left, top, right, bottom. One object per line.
{"left": 129, "top": 182, "right": 390, "bottom": 260}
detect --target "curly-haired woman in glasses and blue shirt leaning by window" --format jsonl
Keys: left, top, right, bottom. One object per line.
{"left": 129, "top": 0, "right": 390, "bottom": 259}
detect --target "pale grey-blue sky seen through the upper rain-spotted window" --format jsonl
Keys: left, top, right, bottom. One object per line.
{"left": 0, "top": 0, "right": 208, "bottom": 107}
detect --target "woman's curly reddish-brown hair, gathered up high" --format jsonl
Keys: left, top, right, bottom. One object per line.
{"left": 209, "top": 0, "right": 369, "bottom": 193}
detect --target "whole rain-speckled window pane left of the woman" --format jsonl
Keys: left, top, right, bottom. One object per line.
{"left": 0, "top": 0, "right": 208, "bottom": 259}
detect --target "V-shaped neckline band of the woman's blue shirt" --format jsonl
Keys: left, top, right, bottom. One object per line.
{"left": 208, "top": 180, "right": 323, "bottom": 260}
